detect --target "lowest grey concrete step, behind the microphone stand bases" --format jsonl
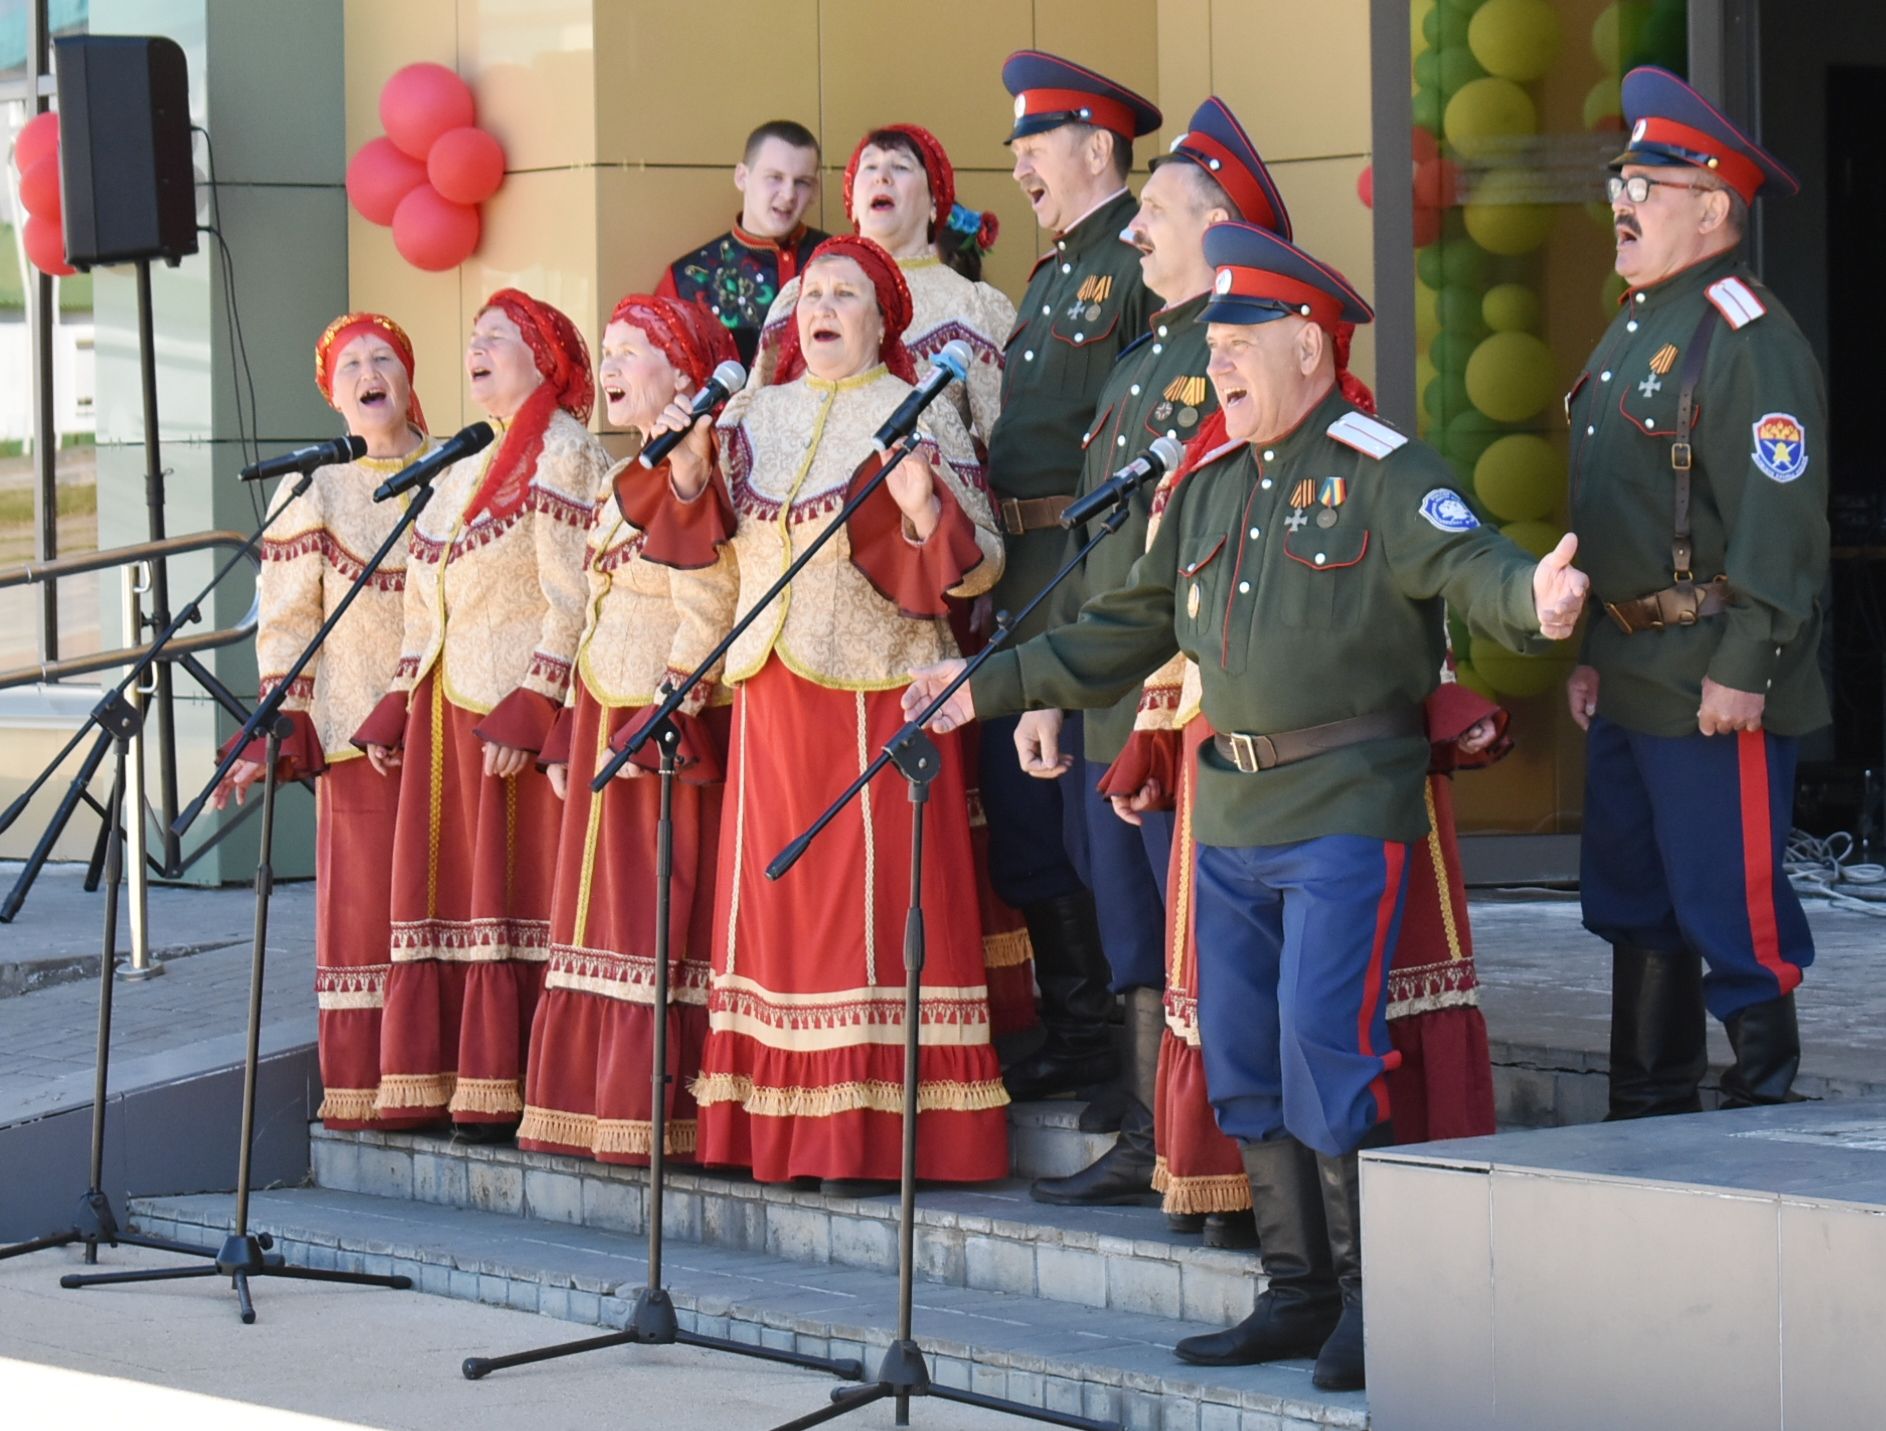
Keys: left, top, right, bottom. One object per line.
{"left": 132, "top": 1184, "right": 1367, "bottom": 1431}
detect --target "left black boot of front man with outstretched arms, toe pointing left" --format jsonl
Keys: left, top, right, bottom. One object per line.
{"left": 1173, "top": 1135, "right": 1341, "bottom": 1367}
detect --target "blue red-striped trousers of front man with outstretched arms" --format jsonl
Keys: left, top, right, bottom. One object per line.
{"left": 1196, "top": 835, "right": 1407, "bottom": 1156}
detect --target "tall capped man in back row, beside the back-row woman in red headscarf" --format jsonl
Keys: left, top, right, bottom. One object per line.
{"left": 981, "top": 49, "right": 1162, "bottom": 1099}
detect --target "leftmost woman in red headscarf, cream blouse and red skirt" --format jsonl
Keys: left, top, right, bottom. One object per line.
{"left": 215, "top": 313, "right": 432, "bottom": 1127}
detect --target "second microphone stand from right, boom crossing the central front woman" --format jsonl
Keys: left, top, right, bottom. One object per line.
{"left": 460, "top": 430, "right": 943, "bottom": 1382}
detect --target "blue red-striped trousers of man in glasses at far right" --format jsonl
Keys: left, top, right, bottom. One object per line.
{"left": 1579, "top": 716, "right": 1814, "bottom": 1018}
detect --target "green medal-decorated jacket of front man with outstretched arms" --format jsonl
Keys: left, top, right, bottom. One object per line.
{"left": 971, "top": 388, "right": 1539, "bottom": 847}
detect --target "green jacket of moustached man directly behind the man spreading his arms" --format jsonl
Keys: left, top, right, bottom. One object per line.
{"left": 1051, "top": 284, "right": 1218, "bottom": 765}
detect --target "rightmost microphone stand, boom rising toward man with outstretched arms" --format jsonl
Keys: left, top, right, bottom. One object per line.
{"left": 766, "top": 492, "right": 1132, "bottom": 1431}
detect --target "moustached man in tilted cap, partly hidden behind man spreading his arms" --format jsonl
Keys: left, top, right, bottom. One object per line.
{"left": 1017, "top": 98, "right": 1290, "bottom": 1246}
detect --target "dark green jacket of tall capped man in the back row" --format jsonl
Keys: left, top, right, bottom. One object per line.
{"left": 988, "top": 190, "right": 1154, "bottom": 637}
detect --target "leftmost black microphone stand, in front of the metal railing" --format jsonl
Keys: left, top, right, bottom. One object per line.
{"left": 0, "top": 471, "right": 328, "bottom": 1265}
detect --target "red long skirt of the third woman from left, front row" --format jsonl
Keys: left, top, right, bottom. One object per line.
{"left": 517, "top": 684, "right": 720, "bottom": 1165}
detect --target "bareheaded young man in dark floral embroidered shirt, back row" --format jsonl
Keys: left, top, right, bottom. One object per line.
{"left": 654, "top": 119, "right": 826, "bottom": 368}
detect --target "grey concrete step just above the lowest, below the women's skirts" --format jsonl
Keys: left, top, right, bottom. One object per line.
{"left": 311, "top": 1126, "right": 1262, "bottom": 1325}
